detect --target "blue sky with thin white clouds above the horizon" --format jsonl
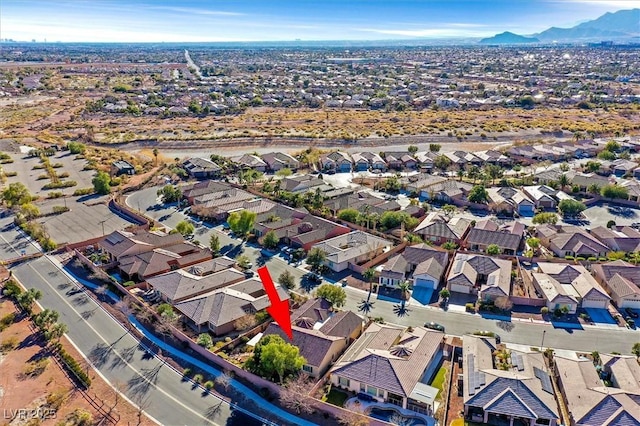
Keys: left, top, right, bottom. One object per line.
{"left": 0, "top": 0, "right": 640, "bottom": 42}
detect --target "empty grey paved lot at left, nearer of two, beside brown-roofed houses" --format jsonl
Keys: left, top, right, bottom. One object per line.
{"left": 37, "top": 196, "right": 132, "bottom": 244}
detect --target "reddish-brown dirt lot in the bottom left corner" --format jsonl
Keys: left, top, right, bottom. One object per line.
{"left": 0, "top": 298, "right": 154, "bottom": 425}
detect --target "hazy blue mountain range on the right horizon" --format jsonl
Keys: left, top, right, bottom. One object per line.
{"left": 480, "top": 9, "right": 640, "bottom": 44}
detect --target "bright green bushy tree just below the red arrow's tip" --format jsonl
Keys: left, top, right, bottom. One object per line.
{"left": 245, "top": 334, "right": 307, "bottom": 383}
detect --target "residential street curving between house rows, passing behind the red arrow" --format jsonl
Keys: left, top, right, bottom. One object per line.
{"left": 127, "top": 187, "right": 640, "bottom": 353}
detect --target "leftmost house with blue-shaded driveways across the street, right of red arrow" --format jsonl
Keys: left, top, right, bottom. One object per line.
{"left": 378, "top": 244, "right": 449, "bottom": 290}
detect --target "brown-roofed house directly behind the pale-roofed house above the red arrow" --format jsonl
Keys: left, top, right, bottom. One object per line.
{"left": 254, "top": 204, "right": 351, "bottom": 251}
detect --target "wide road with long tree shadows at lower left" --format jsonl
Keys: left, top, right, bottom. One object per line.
{"left": 14, "top": 257, "right": 268, "bottom": 425}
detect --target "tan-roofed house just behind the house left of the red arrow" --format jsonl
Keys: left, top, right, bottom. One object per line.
{"left": 147, "top": 267, "right": 246, "bottom": 305}
